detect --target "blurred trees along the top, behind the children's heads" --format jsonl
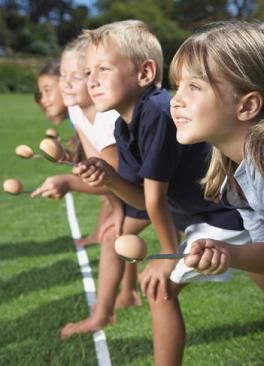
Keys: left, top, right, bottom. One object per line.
{"left": 0, "top": 0, "right": 264, "bottom": 86}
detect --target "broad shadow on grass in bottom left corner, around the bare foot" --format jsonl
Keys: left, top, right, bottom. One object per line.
{"left": 0, "top": 294, "right": 152, "bottom": 366}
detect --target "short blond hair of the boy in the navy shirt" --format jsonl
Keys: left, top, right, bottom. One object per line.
{"left": 79, "top": 20, "right": 163, "bottom": 86}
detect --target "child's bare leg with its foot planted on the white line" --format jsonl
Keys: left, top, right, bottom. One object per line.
{"left": 61, "top": 217, "right": 148, "bottom": 337}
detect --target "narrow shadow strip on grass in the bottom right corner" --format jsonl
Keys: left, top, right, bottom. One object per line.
{"left": 188, "top": 320, "right": 264, "bottom": 346}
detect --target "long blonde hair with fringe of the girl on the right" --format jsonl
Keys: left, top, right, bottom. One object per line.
{"left": 169, "top": 21, "right": 264, "bottom": 201}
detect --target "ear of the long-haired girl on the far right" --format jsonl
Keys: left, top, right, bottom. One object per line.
{"left": 237, "top": 91, "right": 263, "bottom": 121}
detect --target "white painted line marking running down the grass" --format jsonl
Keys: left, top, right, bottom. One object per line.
{"left": 65, "top": 192, "right": 111, "bottom": 366}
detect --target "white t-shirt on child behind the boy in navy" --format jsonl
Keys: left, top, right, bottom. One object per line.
{"left": 68, "top": 105, "right": 119, "bottom": 152}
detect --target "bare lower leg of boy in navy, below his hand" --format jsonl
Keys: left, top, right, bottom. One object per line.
{"left": 149, "top": 281, "right": 185, "bottom": 366}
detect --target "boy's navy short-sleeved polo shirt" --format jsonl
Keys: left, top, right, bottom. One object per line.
{"left": 114, "top": 86, "right": 243, "bottom": 230}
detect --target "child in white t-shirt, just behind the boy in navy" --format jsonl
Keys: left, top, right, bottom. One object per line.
{"left": 32, "top": 41, "right": 149, "bottom": 336}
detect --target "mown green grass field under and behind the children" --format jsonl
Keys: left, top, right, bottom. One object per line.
{"left": 0, "top": 95, "right": 264, "bottom": 366}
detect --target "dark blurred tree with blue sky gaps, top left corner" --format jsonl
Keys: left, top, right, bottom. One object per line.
{"left": 0, "top": 0, "right": 94, "bottom": 55}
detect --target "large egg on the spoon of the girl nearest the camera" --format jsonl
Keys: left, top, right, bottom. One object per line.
{"left": 115, "top": 234, "right": 147, "bottom": 260}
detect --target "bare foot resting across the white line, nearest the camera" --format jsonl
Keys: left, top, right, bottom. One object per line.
{"left": 61, "top": 315, "right": 115, "bottom": 338}
